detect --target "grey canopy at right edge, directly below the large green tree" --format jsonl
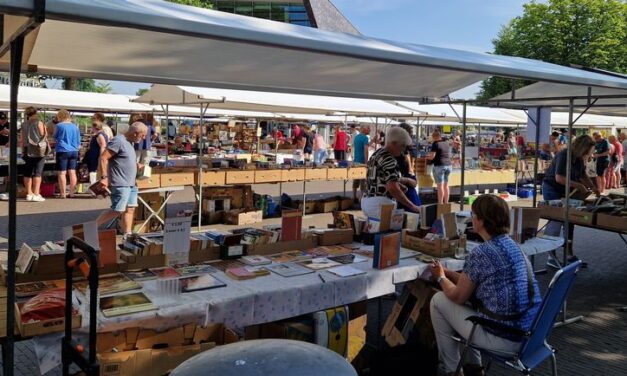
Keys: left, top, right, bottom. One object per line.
{"left": 493, "top": 82, "right": 627, "bottom": 116}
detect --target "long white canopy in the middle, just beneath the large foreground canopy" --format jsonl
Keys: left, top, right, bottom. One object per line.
{"left": 135, "top": 84, "right": 417, "bottom": 116}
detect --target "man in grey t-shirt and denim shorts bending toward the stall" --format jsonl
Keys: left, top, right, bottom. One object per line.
{"left": 96, "top": 121, "right": 148, "bottom": 235}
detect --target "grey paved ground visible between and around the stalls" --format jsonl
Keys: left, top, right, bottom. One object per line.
{"left": 0, "top": 182, "right": 627, "bottom": 376}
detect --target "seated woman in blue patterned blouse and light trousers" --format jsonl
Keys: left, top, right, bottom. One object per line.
{"left": 431, "top": 195, "right": 541, "bottom": 376}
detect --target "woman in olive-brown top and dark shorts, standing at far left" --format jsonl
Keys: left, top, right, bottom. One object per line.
{"left": 22, "top": 107, "right": 49, "bottom": 202}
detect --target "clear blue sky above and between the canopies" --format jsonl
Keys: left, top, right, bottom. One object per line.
{"left": 47, "top": 0, "right": 528, "bottom": 98}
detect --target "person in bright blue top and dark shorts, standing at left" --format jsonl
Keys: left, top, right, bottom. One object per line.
{"left": 54, "top": 110, "right": 81, "bottom": 198}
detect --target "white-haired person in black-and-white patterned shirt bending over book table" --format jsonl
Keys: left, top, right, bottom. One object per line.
{"left": 361, "top": 127, "right": 420, "bottom": 217}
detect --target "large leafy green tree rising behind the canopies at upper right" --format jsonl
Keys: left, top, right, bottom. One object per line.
{"left": 479, "top": 0, "right": 627, "bottom": 99}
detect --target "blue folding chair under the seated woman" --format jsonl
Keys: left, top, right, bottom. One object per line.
{"left": 455, "top": 261, "right": 581, "bottom": 376}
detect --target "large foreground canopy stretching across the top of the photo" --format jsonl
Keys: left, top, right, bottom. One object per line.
{"left": 0, "top": 0, "right": 627, "bottom": 100}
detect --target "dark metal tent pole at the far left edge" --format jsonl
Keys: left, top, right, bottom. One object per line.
{"left": 2, "top": 35, "right": 24, "bottom": 376}
